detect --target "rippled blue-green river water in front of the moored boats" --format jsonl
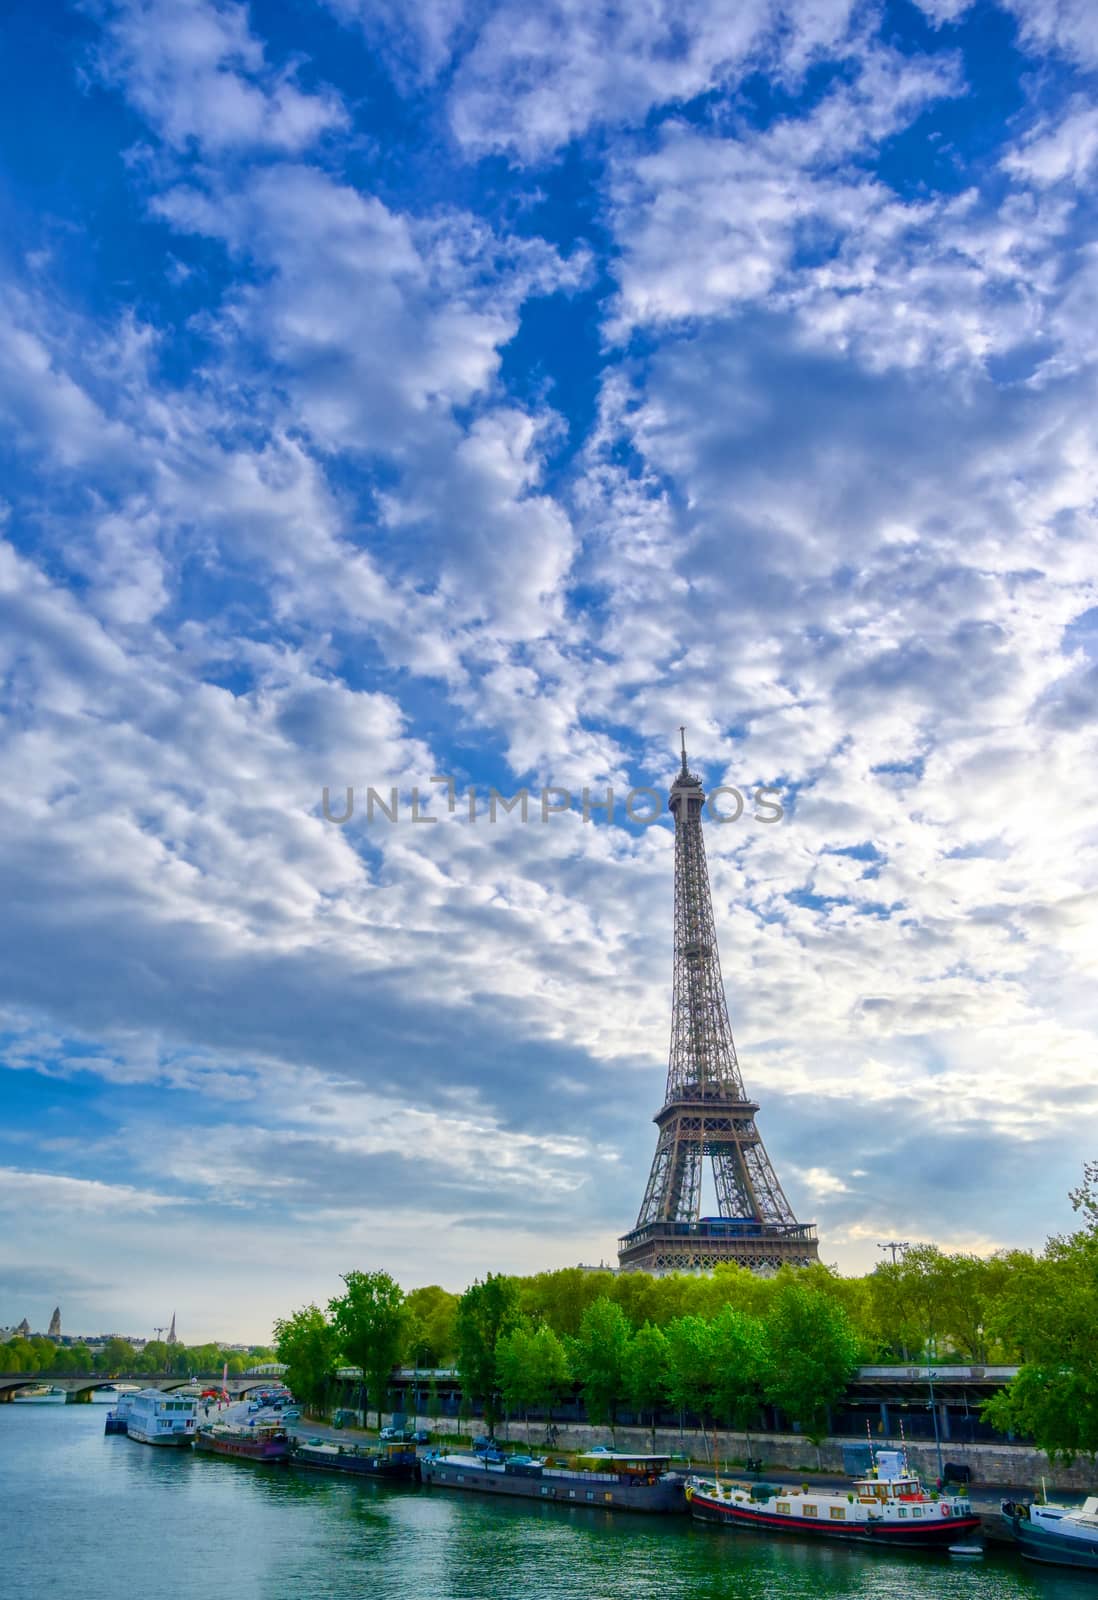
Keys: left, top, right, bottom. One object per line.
{"left": 0, "top": 1405, "right": 1098, "bottom": 1600}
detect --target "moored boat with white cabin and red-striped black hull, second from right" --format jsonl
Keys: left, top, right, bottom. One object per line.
{"left": 687, "top": 1450, "right": 980, "bottom": 1550}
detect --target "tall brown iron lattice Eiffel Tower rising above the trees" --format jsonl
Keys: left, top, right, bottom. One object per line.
{"left": 618, "top": 728, "right": 819, "bottom": 1274}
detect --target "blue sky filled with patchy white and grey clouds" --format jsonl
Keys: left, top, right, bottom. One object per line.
{"left": 0, "top": 0, "right": 1098, "bottom": 1339}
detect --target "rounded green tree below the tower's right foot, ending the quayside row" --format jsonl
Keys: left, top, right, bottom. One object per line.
{"left": 767, "top": 1278, "right": 861, "bottom": 1445}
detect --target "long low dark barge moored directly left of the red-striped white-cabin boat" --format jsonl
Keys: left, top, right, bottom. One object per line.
{"left": 419, "top": 1450, "right": 687, "bottom": 1512}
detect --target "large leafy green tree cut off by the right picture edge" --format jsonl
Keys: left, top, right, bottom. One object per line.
{"left": 983, "top": 1163, "right": 1098, "bottom": 1462}
